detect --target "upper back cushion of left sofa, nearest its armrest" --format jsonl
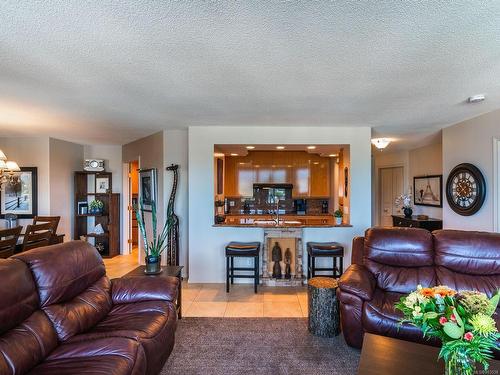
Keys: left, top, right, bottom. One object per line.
{"left": 14, "top": 241, "right": 106, "bottom": 307}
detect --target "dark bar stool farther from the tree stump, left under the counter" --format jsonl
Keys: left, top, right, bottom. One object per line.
{"left": 226, "top": 242, "right": 260, "bottom": 293}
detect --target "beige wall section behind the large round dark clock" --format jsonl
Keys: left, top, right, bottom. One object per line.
{"left": 443, "top": 110, "right": 500, "bottom": 231}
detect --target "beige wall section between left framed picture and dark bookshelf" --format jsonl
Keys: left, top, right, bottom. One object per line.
{"left": 49, "top": 138, "right": 83, "bottom": 241}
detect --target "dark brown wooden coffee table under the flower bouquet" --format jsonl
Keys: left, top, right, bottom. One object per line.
{"left": 358, "top": 333, "right": 500, "bottom": 375}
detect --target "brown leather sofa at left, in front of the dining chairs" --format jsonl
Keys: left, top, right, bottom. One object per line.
{"left": 0, "top": 241, "right": 179, "bottom": 375}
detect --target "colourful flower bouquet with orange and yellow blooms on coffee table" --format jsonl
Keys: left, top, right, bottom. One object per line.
{"left": 395, "top": 285, "right": 500, "bottom": 375}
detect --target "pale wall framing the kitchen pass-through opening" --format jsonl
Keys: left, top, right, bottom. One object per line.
{"left": 189, "top": 126, "right": 371, "bottom": 283}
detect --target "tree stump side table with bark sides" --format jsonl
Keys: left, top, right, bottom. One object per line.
{"left": 307, "top": 277, "right": 340, "bottom": 337}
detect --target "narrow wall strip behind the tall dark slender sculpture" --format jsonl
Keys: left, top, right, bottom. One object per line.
{"left": 163, "top": 129, "right": 189, "bottom": 277}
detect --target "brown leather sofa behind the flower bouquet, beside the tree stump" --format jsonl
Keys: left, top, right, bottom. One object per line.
{"left": 337, "top": 228, "right": 500, "bottom": 354}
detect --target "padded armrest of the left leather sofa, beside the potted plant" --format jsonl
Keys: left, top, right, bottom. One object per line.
{"left": 111, "top": 276, "right": 180, "bottom": 304}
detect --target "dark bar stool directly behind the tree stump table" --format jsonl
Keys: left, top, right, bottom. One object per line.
{"left": 307, "top": 242, "right": 344, "bottom": 279}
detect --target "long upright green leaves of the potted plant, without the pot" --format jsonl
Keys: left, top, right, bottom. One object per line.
{"left": 134, "top": 201, "right": 172, "bottom": 257}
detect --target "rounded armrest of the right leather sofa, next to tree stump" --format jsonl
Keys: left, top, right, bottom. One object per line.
{"left": 339, "top": 264, "right": 376, "bottom": 301}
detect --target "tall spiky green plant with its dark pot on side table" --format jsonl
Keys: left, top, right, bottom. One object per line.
{"left": 134, "top": 201, "right": 171, "bottom": 274}
